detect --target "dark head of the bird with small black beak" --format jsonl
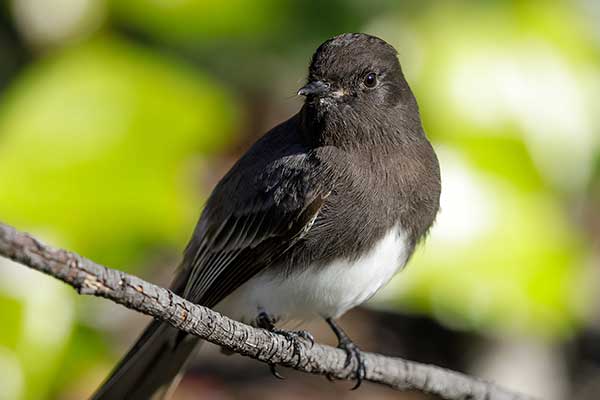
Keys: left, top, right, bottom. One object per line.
{"left": 298, "top": 33, "right": 416, "bottom": 130}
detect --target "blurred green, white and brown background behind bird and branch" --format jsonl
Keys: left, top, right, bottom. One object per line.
{"left": 0, "top": 0, "right": 600, "bottom": 400}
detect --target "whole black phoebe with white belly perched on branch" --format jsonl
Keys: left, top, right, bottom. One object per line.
{"left": 94, "top": 33, "right": 440, "bottom": 400}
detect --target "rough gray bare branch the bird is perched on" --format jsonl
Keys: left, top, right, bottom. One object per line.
{"left": 0, "top": 222, "right": 530, "bottom": 400}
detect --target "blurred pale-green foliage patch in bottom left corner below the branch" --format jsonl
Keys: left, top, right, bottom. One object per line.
{"left": 0, "top": 259, "right": 74, "bottom": 399}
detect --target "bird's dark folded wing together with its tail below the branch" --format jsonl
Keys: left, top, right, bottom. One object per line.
{"left": 94, "top": 156, "right": 327, "bottom": 399}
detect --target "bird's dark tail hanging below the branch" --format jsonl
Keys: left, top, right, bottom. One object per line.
{"left": 92, "top": 320, "right": 199, "bottom": 400}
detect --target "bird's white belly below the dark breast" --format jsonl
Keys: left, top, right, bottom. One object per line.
{"left": 217, "top": 228, "right": 409, "bottom": 322}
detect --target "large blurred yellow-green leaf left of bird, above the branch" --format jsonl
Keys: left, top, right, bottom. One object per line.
{"left": 0, "top": 38, "right": 238, "bottom": 265}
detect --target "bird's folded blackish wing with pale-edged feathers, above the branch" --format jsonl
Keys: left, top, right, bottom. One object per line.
{"left": 179, "top": 164, "right": 327, "bottom": 307}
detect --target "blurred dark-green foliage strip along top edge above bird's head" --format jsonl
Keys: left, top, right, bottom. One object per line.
{"left": 110, "top": 0, "right": 380, "bottom": 45}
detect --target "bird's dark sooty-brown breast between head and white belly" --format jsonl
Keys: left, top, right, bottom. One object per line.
{"left": 282, "top": 137, "right": 440, "bottom": 271}
